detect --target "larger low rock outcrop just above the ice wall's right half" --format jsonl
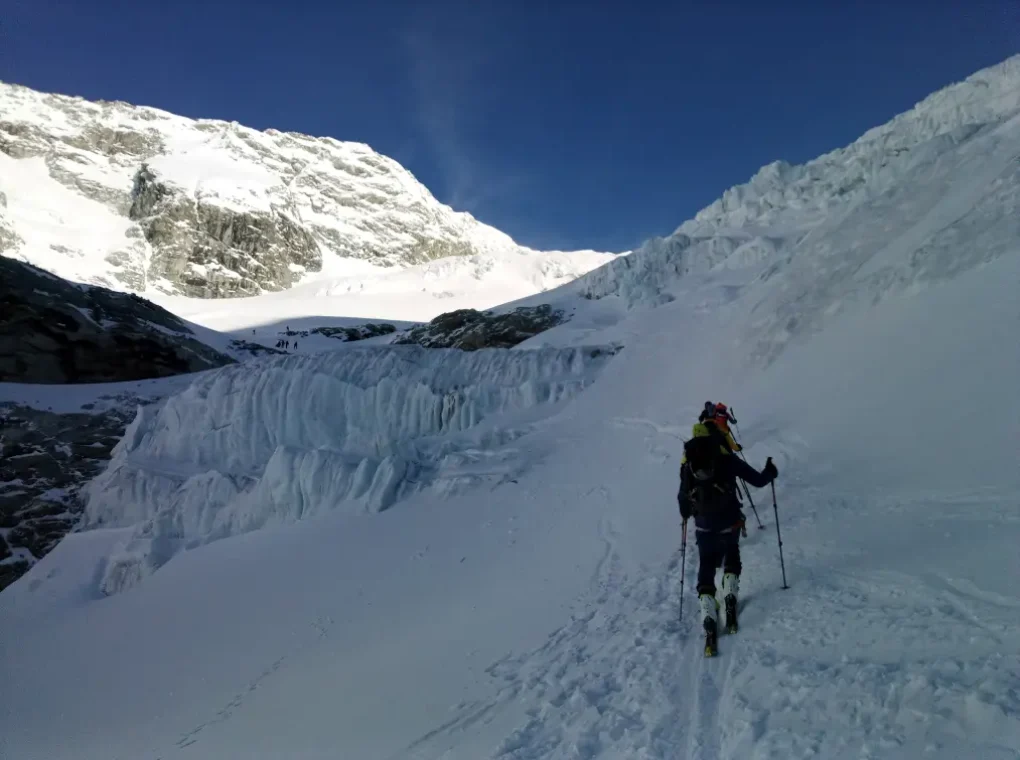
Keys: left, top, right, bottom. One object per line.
{"left": 394, "top": 304, "right": 566, "bottom": 351}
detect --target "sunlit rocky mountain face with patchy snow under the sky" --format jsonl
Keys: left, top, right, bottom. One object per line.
{"left": 0, "top": 83, "right": 591, "bottom": 298}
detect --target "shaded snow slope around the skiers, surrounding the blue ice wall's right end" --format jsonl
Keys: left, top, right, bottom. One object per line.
{"left": 0, "top": 54, "right": 1020, "bottom": 760}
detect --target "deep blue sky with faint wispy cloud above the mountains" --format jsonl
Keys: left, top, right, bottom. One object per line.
{"left": 0, "top": 0, "right": 1020, "bottom": 250}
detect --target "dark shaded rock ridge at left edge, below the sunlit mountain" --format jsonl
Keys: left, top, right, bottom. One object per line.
{"left": 0, "top": 257, "right": 233, "bottom": 384}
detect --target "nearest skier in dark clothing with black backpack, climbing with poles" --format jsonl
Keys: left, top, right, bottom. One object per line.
{"left": 676, "top": 420, "right": 778, "bottom": 653}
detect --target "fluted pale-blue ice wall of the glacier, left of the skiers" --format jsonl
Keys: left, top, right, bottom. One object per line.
{"left": 86, "top": 347, "right": 609, "bottom": 593}
